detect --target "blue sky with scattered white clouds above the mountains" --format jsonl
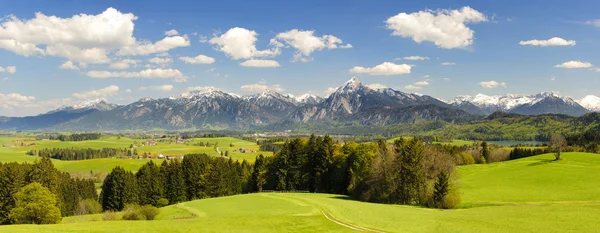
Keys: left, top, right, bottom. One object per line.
{"left": 0, "top": 0, "right": 600, "bottom": 116}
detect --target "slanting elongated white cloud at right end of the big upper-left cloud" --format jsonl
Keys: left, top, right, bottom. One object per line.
{"left": 117, "top": 36, "right": 190, "bottom": 56}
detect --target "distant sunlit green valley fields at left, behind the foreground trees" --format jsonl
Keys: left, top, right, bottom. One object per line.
{"left": 0, "top": 137, "right": 273, "bottom": 173}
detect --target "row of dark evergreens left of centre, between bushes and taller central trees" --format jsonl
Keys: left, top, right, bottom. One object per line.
{"left": 100, "top": 154, "right": 251, "bottom": 211}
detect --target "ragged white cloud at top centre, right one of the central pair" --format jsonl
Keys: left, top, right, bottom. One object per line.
{"left": 270, "top": 29, "right": 352, "bottom": 62}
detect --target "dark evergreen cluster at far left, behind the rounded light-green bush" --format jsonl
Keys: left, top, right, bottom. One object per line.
{"left": 0, "top": 157, "right": 98, "bottom": 224}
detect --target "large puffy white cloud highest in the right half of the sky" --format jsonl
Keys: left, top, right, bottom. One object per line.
{"left": 386, "top": 6, "right": 488, "bottom": 49}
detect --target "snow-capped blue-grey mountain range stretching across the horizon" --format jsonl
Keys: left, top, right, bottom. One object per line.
{"left": 0, "top": 78, "right": 600, "bottom": 131}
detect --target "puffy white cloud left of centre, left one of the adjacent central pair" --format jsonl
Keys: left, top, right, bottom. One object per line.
{"left": 208, "top": 27, "right": 281, "bottom": 60}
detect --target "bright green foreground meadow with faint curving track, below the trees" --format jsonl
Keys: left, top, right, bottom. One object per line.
{"left": 0, "top": 153, "right": 600, "bottom": 232}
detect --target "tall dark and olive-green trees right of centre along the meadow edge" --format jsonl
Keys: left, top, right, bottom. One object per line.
{"left": 249, "top": 135, "right": 458, "bottom": 208}
